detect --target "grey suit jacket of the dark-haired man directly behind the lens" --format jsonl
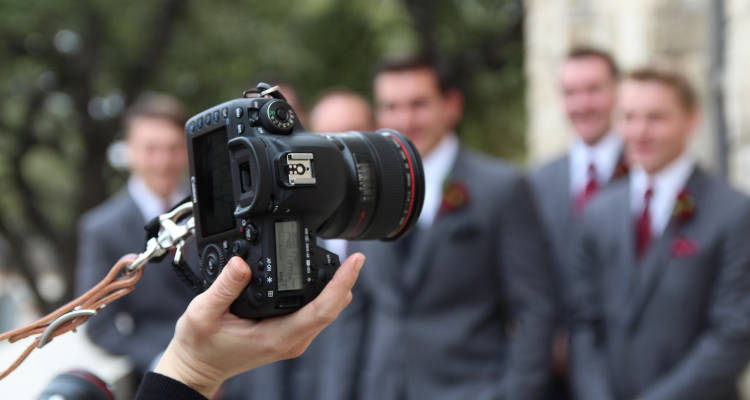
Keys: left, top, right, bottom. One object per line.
{"left": 324, "top": 149, "right": 555, "bottom": 399}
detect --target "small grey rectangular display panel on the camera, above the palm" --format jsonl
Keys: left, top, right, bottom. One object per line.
{"left": 275, "top": 221, "right": 302, "bottom": 292}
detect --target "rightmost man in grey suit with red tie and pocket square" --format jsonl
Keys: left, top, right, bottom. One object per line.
{"left": 571, "top": 69, "right": 750, "bottom": 400}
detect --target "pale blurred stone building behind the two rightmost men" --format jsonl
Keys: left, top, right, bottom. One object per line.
{"left": 524, "top": 0, "right": 750, "bottom": 194}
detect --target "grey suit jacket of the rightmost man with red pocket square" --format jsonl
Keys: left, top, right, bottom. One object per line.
{"left": 571, "top": 169, "right": 750, "bottom": 400}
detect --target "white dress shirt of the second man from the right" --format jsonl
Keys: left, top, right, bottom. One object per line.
{"left": 570, "top": 132, "right": 623, "bottom": 197}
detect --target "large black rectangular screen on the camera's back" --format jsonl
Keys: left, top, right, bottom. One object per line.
{"left": 193, "top": 128, "right": 234, "bottom": 236}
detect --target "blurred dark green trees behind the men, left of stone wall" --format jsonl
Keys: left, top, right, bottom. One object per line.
{"left": 0, "top": 0, "right": 525, "bottom": 310}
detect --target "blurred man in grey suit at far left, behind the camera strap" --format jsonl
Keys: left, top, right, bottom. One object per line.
{"left": 76, "top": 95, "right": 193, "bottom": 382}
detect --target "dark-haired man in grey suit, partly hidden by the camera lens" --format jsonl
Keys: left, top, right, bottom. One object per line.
{"left": 326, "top": 57, "right": 554, "bottom": 400}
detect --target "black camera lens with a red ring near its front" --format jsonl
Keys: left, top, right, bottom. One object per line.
{"left": 319, "top": 130, "right": 424, "bottom": 240}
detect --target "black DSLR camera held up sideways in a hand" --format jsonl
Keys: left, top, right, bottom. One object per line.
{"left": 185, "top": 83, "right": 424, "bottom": 319}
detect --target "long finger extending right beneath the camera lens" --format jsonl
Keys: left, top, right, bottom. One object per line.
{"left": 290, "top": 253, "right": 365, "bottom": 337}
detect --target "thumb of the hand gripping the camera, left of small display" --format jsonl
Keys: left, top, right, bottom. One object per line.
{"left": 200, "top": 257, "right": 252, "bottom": 316}
